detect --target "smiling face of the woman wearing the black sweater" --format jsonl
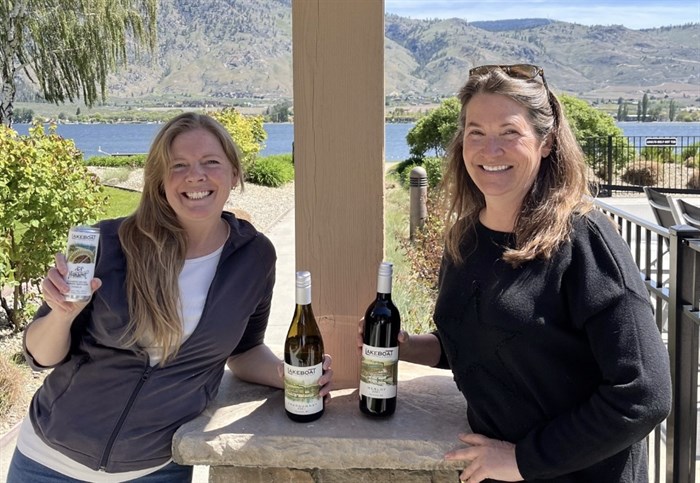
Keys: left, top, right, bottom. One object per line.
{"left": 462, "top": 93, "right": 551, "bottom": 213}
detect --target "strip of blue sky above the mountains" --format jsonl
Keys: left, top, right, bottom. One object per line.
{"left": 384, "top": 0, "right": 700, "bottom": 29}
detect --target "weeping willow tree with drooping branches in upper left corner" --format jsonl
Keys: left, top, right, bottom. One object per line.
{"left": 0, "top": 0, "right": 157, "bottom": 126}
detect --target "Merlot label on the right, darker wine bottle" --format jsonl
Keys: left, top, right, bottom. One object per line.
{"left": 360, "top": 344, "right": 399, "bottom": 399}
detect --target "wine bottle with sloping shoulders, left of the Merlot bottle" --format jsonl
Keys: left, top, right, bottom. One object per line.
{"left": 284, "top": 272, "right": 325, "bottom": 423}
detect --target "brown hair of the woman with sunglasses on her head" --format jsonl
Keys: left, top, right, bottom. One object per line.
{"left": 443, "top": 69, "right": 592, "bottom": 267}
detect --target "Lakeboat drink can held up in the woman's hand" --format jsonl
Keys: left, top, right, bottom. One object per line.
{"left": 65, "top": 226, "right": 100, "bottom": 302}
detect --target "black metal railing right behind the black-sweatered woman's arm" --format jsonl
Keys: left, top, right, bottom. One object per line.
{"left": 595, "top": 199, "right": 700, "bottom": 483}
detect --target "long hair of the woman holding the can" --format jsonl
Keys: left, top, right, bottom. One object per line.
{"left": 119, "top": 113, "right": 243, "bottom": 364}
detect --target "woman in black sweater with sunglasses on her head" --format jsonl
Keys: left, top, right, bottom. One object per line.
{"left": 361, "top": 65, "right": 671, "bottom": 483}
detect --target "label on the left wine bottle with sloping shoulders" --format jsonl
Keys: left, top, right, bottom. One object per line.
{"left": 284, "top": 363, "right": 323, "bottom": 415}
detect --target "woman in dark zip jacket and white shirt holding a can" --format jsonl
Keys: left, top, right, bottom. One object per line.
{"left": 7, "top": 113, "right": 332, "bottom": 483}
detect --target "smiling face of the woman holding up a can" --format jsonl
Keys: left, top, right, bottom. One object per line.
{"left": 163, "top": 128, "right": 238, "bottom": 229}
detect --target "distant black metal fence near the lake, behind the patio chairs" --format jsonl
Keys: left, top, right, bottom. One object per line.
{"left": 580, "top": 134, "right": 700, "bottom": 196}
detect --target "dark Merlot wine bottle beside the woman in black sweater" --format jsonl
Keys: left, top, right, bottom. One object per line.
{"left": 360, "top": 262, "right": 401, "bottom": 417}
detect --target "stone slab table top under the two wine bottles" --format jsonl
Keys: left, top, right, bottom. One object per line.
{"left": 173, "top": 362, "right": 469, "bottom": 470}
